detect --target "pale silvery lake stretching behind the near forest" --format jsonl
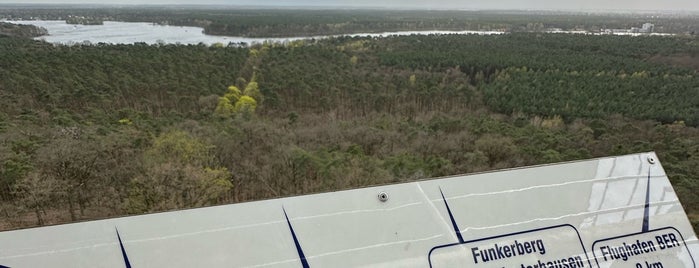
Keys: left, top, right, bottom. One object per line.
{"left": 4, "top": 20, "right": 504, "bottom": 45}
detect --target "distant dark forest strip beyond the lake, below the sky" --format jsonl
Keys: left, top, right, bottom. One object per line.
{"left": 0, "top": 5, "right": 699, "bottom": 37}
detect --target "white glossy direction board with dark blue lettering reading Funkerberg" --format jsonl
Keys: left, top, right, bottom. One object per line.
{"left": 0, "top": 153, "right": 699, "bottom": 268}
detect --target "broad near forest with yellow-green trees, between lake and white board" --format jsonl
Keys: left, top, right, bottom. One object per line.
{"left": 0, "top": 25, "right": 699, "bottom": 230}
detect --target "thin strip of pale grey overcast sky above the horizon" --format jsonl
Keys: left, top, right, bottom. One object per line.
{"left": 0, "top": 0, "right": 699, "bottom": 11}
